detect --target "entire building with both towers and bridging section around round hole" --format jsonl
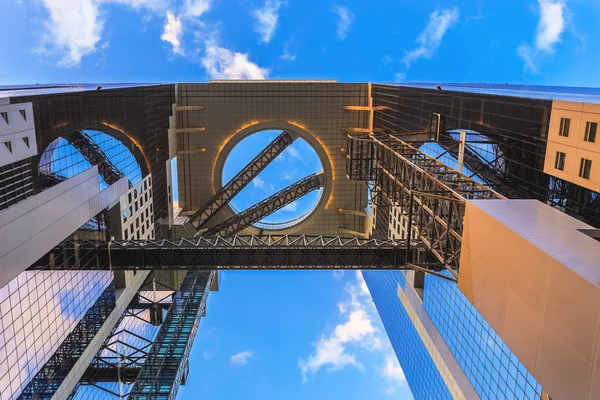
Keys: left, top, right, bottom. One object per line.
{"left": 0, "top": 81, "right": 600, "bottom": 400}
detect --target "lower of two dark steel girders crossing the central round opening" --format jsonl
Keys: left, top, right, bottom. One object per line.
{"left": 203, "top": 172, "right": 325, "bottom": 236}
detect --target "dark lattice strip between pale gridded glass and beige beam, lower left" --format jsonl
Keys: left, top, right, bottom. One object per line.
{"left": 19, "top": 284, "right": 116, "bottom": 400}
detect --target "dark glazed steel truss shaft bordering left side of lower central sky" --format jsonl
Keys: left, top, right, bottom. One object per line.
{"left": 128, "top": 271, "right": 215, "bottom": 400}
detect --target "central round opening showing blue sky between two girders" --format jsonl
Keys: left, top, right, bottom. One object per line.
{"left": 221, "top": 130, "right": 323, "bottom": 229}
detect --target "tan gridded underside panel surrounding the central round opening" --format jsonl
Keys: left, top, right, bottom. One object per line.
{"left": 172, "top": 82, "right": 368, "bottom": 236}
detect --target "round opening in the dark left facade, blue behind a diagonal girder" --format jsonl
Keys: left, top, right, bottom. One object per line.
{"left": 39, "top": 130, "right": 142, "bottom": 190}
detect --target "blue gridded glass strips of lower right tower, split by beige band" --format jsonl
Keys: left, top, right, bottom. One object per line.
{"left": 363, "top": 271, "right": 542, "bottom": 400}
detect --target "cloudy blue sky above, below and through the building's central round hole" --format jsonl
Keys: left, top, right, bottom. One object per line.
{"left": 0, "top": 0, "right": 600, "bottom": 399}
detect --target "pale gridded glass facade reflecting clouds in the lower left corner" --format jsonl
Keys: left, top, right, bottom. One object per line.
{"left": 0, "top": 271, "right": 112, "bottom": 400}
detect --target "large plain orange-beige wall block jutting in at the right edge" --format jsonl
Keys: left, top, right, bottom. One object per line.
{"left": 458, "top": 200, "right": 600, "bottom": 400}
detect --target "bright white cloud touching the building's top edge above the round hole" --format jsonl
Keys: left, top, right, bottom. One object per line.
{"left": 202, "top": 39, "right": 270, "bottom": 79}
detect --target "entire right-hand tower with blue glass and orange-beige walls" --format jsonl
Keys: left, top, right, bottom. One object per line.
{"left": 363, "top": 84, "right": 600, "bottom": 399}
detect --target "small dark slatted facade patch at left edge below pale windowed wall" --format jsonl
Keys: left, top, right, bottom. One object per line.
{"left": 0, "top": 160, "right": 33, "bottom": 210}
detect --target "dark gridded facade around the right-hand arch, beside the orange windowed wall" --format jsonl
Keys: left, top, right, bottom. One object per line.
{"left": 372, "top": 85, "right": 600, "bottom": 226}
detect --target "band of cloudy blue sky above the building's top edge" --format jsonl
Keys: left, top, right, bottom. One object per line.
{"left": 0, "top": 0, "right": 600, "bottom": 86}
